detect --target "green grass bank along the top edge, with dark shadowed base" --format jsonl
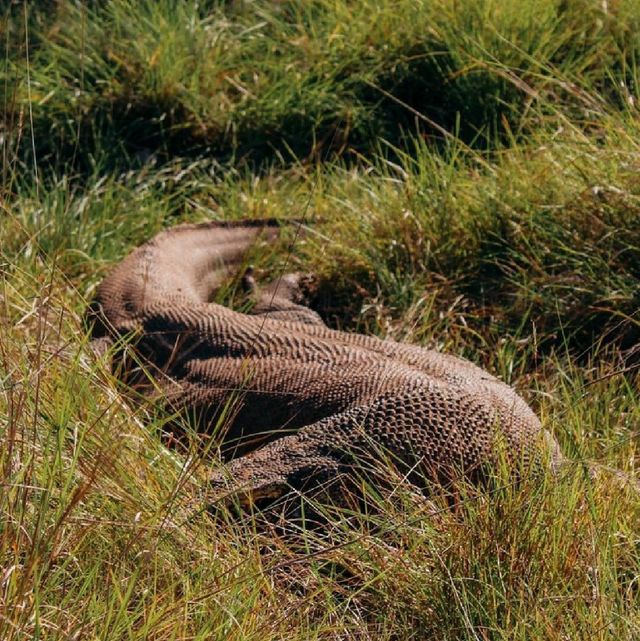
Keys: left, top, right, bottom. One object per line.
{"left": 5, "top": 0, "right": 638, "bottom": 170}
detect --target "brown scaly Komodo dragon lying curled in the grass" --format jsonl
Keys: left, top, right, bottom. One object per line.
{"left": 93, "top": 221, "right": 562, "bottom": 510}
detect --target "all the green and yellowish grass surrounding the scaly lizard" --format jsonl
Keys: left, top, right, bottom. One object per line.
{"left": 0, "top": 0, "right": 640, "bottom": 641}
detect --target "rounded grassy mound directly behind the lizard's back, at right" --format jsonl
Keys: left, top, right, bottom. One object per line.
{"left": 292, "top": 121, "right": 640, "bottom": 355}
